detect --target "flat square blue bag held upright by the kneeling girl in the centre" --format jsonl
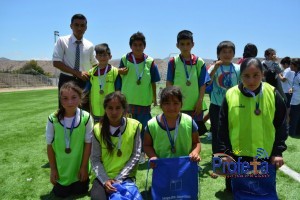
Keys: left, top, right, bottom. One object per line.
{"left": 151, "top": 156, "right": 198, "bottom": 199}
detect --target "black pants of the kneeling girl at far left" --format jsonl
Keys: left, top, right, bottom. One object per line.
{"left": 52, "top": 179, "right": 90, "bottom": 198}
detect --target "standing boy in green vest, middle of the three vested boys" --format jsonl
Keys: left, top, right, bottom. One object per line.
{"left": 119, "top": 32, "right": 160, "bottom": 164}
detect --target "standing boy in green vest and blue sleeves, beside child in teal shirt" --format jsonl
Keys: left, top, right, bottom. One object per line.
{"left": 166, "top": 30, "right": 210, "bottom": 135}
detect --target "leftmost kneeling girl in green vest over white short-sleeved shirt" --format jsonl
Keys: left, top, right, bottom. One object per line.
{"left": 46, "top": 82, "right": 93, "bottom": 197}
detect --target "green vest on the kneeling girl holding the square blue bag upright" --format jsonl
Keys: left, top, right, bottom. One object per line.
{"left": 148, "top": 113, "right": 193, "bottom": 158}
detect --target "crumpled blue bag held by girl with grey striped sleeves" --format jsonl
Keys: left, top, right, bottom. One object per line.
{"left": 108, "top": 181, "right": 143, "bottom": 200}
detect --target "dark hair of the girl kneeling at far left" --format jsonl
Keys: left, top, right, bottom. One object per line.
{"left": 55, "top": 81, "right": 83, "bottom": 120}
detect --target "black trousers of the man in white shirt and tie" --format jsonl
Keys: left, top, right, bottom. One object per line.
{"left": 58, "top": 73, "right": 90, "bottom": 112}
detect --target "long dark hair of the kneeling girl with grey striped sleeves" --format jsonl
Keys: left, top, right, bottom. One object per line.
{"left": 99, "top": 91, "right": 127, "bottom": 154}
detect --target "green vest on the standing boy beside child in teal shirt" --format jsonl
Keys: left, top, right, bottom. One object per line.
{"left": 174, "top": 55, "right": 207, "bottom": 111}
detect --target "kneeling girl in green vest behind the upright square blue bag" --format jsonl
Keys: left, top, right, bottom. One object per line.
{"left": 144, "top": 86, "right": 201, "bottom": 164}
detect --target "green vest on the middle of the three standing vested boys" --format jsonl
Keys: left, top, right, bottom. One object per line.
{"left": 121, "top": 55, "right": 153, "bottom": 106}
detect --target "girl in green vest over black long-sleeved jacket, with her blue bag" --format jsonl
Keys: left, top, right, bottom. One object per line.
{"left": 218, "top": 58, "right": 287, "bottom": 199}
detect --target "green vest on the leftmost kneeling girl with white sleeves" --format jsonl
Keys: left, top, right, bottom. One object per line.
{"left": 49, "top": 110, "right": 90, "bottom": 186}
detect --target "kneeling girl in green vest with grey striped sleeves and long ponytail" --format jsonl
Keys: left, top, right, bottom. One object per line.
{"left": 91, "top": 91, "right": 142, "bottom": 200}
